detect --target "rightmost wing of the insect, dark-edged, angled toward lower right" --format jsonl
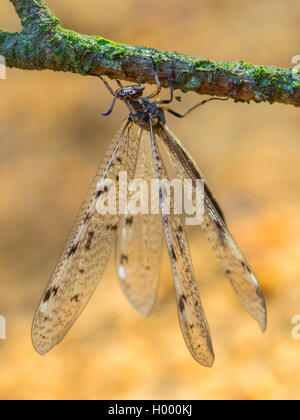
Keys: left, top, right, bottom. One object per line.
{"left": 161, "top": 126, "right": 266, "bottom": 331}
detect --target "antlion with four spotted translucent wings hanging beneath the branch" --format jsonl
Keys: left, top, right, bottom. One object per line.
{"left": 32, "top": 60, "right": 266, "bottom": 366}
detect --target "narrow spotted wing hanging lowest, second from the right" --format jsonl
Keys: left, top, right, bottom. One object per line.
{"left": 150, "top": 123, "right": 214, "bottom": 367}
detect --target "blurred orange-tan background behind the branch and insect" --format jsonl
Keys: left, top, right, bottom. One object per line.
{"left": 0, "top": 0, "right": 300, "bottom": 399}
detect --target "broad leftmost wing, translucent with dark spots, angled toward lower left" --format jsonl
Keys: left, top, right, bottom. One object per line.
{"left": 32, "top": 122, "right": 139, "bottom": 354}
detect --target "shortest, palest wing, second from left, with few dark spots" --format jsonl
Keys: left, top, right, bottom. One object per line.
{"left": 116, "top": 131, "right": 162, "bottom": 316}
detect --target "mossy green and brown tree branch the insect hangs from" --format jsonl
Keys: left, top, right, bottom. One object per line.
{"left": 0, "top": 0, "right": 300, "bottom": 106}
